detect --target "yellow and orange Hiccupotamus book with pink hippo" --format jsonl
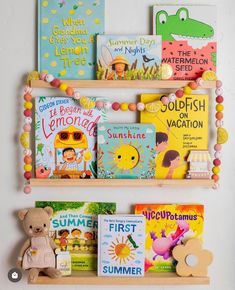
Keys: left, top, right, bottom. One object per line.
{"left": 135, "top": 204, "right": 204, "bottom": 272}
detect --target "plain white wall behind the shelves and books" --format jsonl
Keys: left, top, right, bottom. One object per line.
{"left": 0, "top": 0, "right": 235, "bottom": 290}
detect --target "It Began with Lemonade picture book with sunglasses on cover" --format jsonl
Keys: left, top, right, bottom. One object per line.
{"left": 35, "top": 96, "right": 106, "bottom": 179}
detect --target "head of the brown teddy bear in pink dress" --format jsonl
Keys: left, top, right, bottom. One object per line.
{"left": 18, "top": 207, "right": 53, "bottom": 237}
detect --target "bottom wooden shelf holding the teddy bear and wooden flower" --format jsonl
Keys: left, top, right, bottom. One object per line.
{"left": 29, "top": 271, "right": 210, "bottom": 285}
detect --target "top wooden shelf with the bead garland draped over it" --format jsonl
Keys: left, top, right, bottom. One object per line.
{"left": 30, "top": 80, "right": 216, "bottom": 89}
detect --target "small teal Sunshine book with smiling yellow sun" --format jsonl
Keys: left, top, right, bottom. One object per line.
{"left": 97, "top": 123, "right": 156, "bottom": 179}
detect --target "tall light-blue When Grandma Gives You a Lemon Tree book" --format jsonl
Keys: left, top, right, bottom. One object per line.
{"left": 38, "top": 0, "right": 105, "bottom": 80}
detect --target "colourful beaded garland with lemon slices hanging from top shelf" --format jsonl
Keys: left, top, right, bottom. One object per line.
{"left": 20, "top": 73, "right": 228, "bottom": 194}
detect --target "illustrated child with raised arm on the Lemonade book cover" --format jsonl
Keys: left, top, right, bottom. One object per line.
{"left": 61, "top": 147, "right": 83, "bottom": 171}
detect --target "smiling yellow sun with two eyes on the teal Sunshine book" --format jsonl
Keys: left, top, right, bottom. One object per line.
{"left": 109, "top": 140, "right": 143, "bottom": 174}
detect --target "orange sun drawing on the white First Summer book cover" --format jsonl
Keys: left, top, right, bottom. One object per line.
{"left": 109, "top": 237, "right": 135, "bottom": 265}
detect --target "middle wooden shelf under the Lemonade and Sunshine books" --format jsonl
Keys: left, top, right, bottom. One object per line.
{"left": 30, "top": 178, "right": 214, "bottom": 187}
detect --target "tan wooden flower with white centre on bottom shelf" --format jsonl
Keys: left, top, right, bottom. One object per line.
{"left": 172, "top": 239, "right": 213, "bottom": 277}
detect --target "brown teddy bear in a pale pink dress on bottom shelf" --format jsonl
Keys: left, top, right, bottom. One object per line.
{"left": 17, "top": 207, "right": 61, "bottom": 283}
